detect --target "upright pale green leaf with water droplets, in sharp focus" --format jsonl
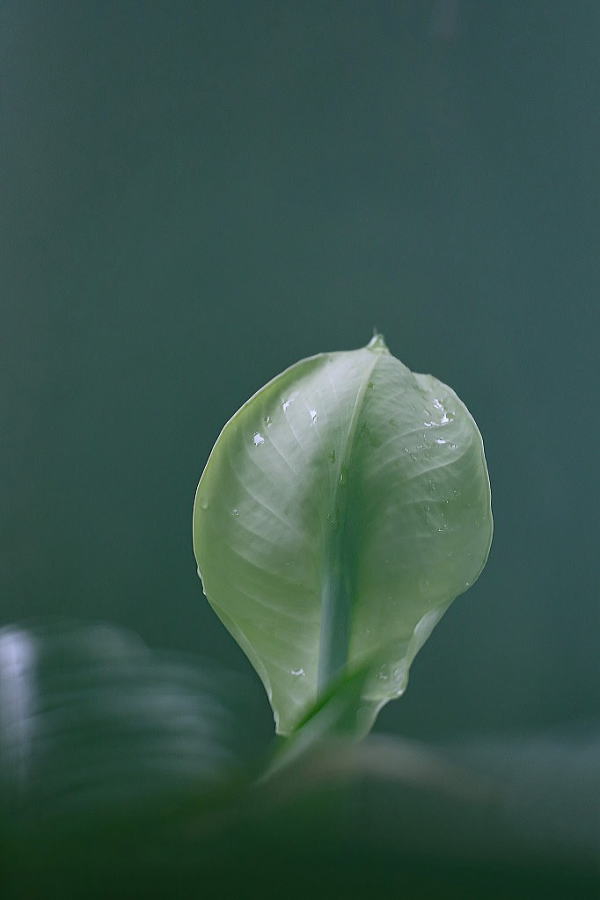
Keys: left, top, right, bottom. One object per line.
{"left": 194, "top": 336, "right": 492, "bottom": 734}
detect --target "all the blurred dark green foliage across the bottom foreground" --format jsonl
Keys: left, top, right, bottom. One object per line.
{"left": 0, "top": 626, "right": 600, "bottom": 900}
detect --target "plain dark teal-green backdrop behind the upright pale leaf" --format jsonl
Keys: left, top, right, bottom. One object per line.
{"left": 0, "top": 0, "right": 600, "bottom": 739}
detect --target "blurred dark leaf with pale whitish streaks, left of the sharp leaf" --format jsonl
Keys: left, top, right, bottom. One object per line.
{"left": 0, "top": 625, "right": 262, "bottom": 827}
